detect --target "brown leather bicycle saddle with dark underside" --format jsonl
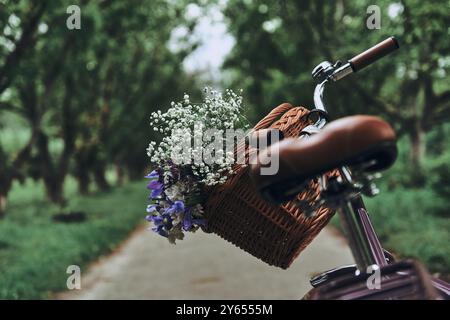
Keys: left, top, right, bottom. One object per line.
{"left": 250, "top": 115, "right": 397, "bottom": 203}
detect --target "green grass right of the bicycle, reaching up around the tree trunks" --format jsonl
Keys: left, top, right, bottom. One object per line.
{"left": 333, "top": 134, "right": 450, "bottom": 280}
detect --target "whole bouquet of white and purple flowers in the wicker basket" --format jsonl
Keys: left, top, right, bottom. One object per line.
{"left": 146, "top": 88, "right": 244, "bottom": 243}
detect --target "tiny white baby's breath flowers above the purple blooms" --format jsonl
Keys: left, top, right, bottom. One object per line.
{"left": 147, "top": 87, "right": 243, "bottom": 186}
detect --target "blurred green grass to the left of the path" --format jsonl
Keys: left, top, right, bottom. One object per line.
{"left": 0, "top": 179, "right": 146, "bottom": 299}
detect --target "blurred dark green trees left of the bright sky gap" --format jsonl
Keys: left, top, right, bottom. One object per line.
{"left": 0, "top": 1, "right": 197, "bottom": 215}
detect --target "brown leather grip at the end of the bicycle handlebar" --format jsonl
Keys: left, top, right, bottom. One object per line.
{"left": 349, "top": 37, "right": 399, "bottom": 72}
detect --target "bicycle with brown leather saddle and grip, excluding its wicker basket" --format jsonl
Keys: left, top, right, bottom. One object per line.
{"left": 250, "top": 37, "right": 450, "bottom": 299}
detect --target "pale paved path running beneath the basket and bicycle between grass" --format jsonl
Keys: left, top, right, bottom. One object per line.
{"left": 55, "top": 227, "right": 353, "bottom": 299}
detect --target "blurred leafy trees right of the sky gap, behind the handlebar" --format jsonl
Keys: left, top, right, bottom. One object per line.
{"left": 224, "top": 0, "right": 450, "bottom": 183}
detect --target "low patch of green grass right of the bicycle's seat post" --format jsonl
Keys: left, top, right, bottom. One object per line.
{"left": 333, "top": 180, "right": 450, "bottom": 279}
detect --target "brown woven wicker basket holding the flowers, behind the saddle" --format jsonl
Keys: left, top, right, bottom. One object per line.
{"left": 204, "top": 103, "right": 334, "bottom": 269}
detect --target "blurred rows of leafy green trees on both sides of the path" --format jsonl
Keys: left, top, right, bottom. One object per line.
{"left": 0, "top": 0, "right": 450, "bottom": 212}
